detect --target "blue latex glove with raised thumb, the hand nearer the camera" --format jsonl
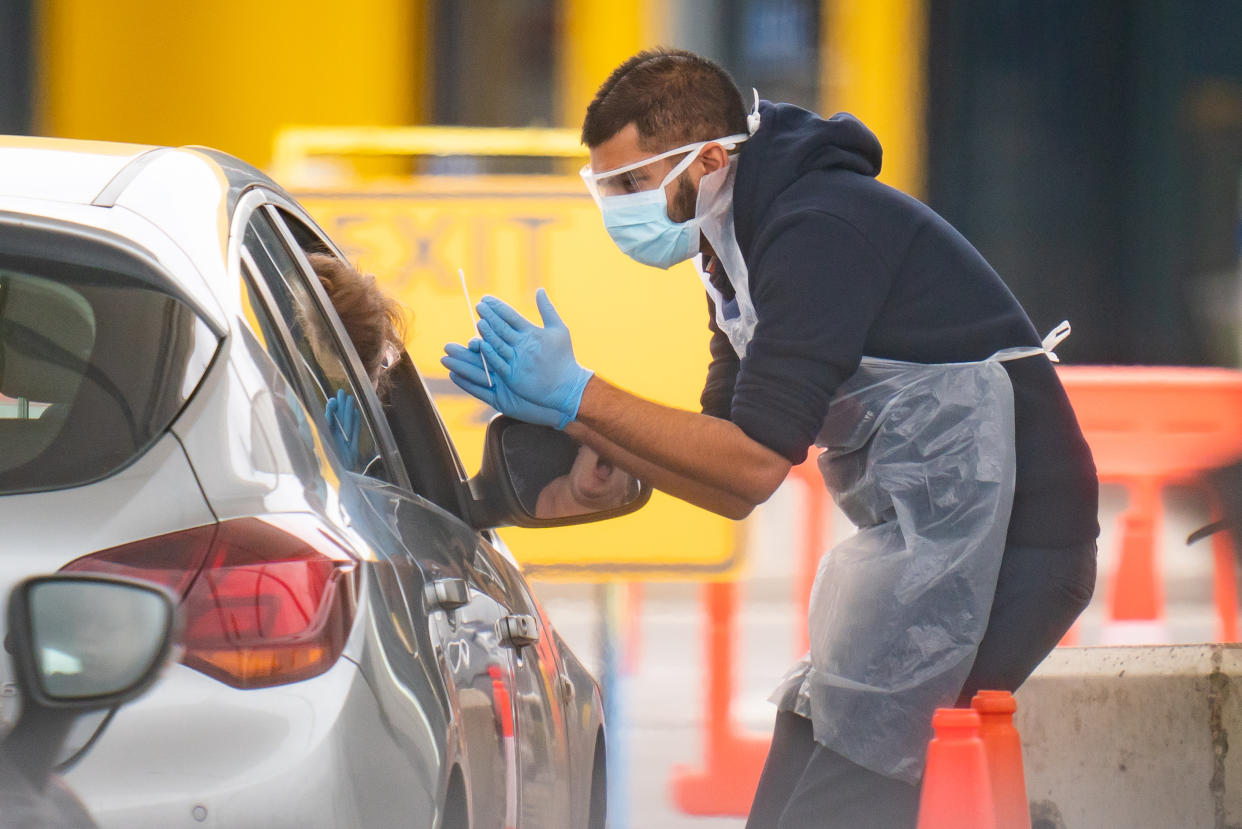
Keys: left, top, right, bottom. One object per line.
{"left": 478, "top": 288, "right": 594, "bottom": 429}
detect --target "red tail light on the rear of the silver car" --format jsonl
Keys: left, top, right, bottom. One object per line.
{"left": 63, "top": 516, "right": 356, "bottom": 689}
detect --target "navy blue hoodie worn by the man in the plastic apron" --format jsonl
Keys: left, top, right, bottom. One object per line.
{"left": 702, "top": 102, "right": 1099, "bottom": 547}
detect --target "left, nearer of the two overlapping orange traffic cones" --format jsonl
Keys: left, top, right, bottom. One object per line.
{"left": 918, "top": 708, "right": 997, "bottom": 829}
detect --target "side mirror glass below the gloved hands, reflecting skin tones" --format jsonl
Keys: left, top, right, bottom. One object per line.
{"left": 469, "top": 415, "right": 651, "bottom": 527}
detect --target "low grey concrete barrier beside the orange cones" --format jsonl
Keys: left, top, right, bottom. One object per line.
{"left": 1016, "top": 645, "right": 1242, "bottom": 829}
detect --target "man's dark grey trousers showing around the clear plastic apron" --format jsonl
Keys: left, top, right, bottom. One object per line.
{"left": 746, "top": 542, "right": 1095, "bottom": 829}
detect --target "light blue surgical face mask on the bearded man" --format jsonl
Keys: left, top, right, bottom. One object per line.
{"left": 599, "top": 148, "right": 702, "bottom": 268}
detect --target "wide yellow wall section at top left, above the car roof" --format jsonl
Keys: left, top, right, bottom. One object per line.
{"left": 36, "top": 0, "right": 430, "bottom": 165}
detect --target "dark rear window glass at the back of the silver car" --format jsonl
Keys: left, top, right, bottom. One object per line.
{"left": 0, "top": 222, "right": 220, "bottom": 495}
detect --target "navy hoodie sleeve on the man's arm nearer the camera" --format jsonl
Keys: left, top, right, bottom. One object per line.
{"left": 730, "top": 210, "right": 892, "bottom": 464}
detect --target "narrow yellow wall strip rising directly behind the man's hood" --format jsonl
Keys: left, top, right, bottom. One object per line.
{"left": 820, "top": 0, "right": 927, "bottom": 196}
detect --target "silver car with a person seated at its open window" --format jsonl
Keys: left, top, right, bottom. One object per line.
{"left": 0, "top": 138, "right": 650, "bottom": 829}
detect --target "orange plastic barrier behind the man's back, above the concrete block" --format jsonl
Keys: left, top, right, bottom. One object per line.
{"left": 1058, "top": 365, "right": 1242, "bottom": 641}
